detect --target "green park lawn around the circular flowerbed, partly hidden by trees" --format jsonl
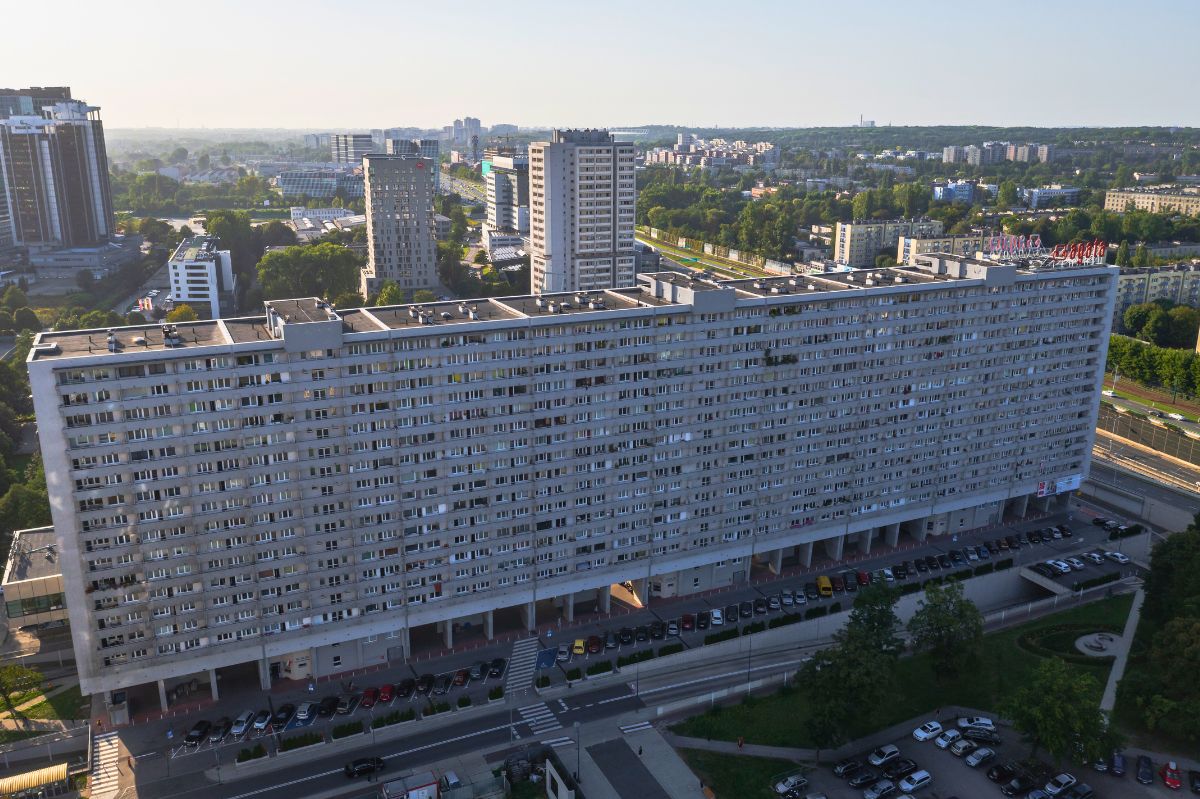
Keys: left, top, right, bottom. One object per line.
{"left": 672, "top": 594, "right": 1133, "bottom": 746}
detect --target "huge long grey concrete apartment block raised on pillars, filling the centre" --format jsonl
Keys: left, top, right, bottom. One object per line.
{"left": 29, "top": 255, "right": 1117, "bottom": 701}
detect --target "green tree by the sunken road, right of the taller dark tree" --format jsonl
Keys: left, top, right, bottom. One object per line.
{"left": 908, "top": 581, "right": 983, "bottom": 680}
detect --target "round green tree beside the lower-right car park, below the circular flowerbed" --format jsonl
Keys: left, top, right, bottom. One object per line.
{"left": 1003, "top": 657, "right": 1111, "bottom": 763}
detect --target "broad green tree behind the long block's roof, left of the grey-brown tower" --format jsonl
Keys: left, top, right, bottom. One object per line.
{"left": 258, "top": 242, "right": 361, "bottom": 300}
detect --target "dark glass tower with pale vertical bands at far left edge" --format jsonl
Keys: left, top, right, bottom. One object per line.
{"left": 0, "top": 101, "right": 113, "bottom": 248}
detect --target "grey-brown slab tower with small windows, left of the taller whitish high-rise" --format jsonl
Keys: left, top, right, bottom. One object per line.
{"left": 361, "top": 154, "right": 438, "bottom": 296}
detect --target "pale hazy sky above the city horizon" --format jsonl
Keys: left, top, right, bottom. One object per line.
{"left": 0, "top": 0, "right": 1200, "bottom": 130}
